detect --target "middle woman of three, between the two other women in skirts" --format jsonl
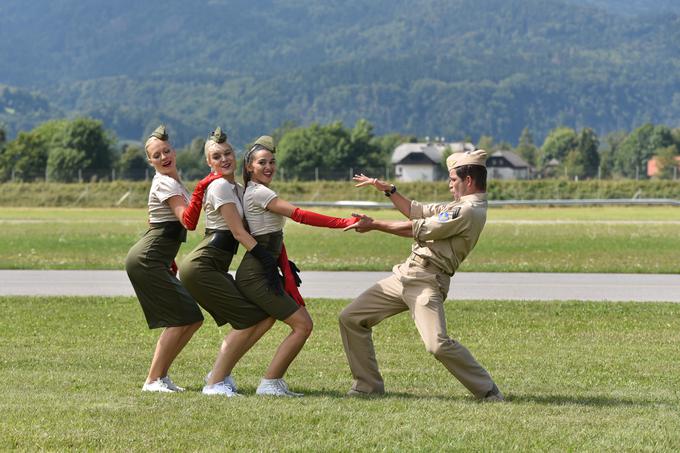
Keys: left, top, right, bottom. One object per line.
{"left": 181, "top": 128, "right": 274, "bottom": 397}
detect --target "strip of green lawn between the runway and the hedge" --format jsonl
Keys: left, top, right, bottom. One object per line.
{"left": 0, "top": 207, "right": 680, "bottom": 273}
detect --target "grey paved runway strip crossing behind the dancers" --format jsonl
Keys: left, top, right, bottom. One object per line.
{"left": 0, "top": 270, "right": 680, "bottom": 302}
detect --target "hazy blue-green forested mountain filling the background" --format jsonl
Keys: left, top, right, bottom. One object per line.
{"left": 0, "top": 0, "right": 680, "bottom": 144}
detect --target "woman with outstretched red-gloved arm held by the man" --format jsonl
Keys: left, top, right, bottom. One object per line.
{"left": 236, "top": 136, "right": 358, "bottom": 396}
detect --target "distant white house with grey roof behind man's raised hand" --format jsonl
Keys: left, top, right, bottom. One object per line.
{"left": 392, "top": 142, "right": 475, "bottom": 181}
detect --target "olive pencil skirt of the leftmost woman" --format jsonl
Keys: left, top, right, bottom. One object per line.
{"left": 125, "top": 222, "right": 203, "bottom": 329}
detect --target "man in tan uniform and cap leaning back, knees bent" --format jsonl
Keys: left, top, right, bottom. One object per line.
{"left": 340, "top": 150, "right": 504, "bottom": 401}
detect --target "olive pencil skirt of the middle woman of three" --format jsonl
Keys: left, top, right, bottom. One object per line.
{"left": 180, "top": 231, "right": 269, "bottom": 329}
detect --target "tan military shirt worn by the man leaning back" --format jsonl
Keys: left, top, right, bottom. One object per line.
{"left": 410, "top": 193, "right": 488, "bottom": 275}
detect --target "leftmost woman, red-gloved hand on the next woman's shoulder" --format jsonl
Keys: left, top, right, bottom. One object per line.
{"left": 125, "top": 126, "right": 219, "bottom": 392}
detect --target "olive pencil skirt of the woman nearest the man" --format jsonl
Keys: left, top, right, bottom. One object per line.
{"left": 236, "top": 231, "right": 300, "bottom": 321}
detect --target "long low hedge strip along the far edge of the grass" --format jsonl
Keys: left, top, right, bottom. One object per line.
{"left": 0, "top": 179, "right": 680, "bottom": 208}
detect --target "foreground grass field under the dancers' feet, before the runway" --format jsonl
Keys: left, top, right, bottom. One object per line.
{"left": 0, "top": 297, "right": 680, "bottom": 451}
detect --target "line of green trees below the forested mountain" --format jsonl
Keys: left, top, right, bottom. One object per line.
{"left": 0, "top": 117, "right": 680, "bottom": 182}
